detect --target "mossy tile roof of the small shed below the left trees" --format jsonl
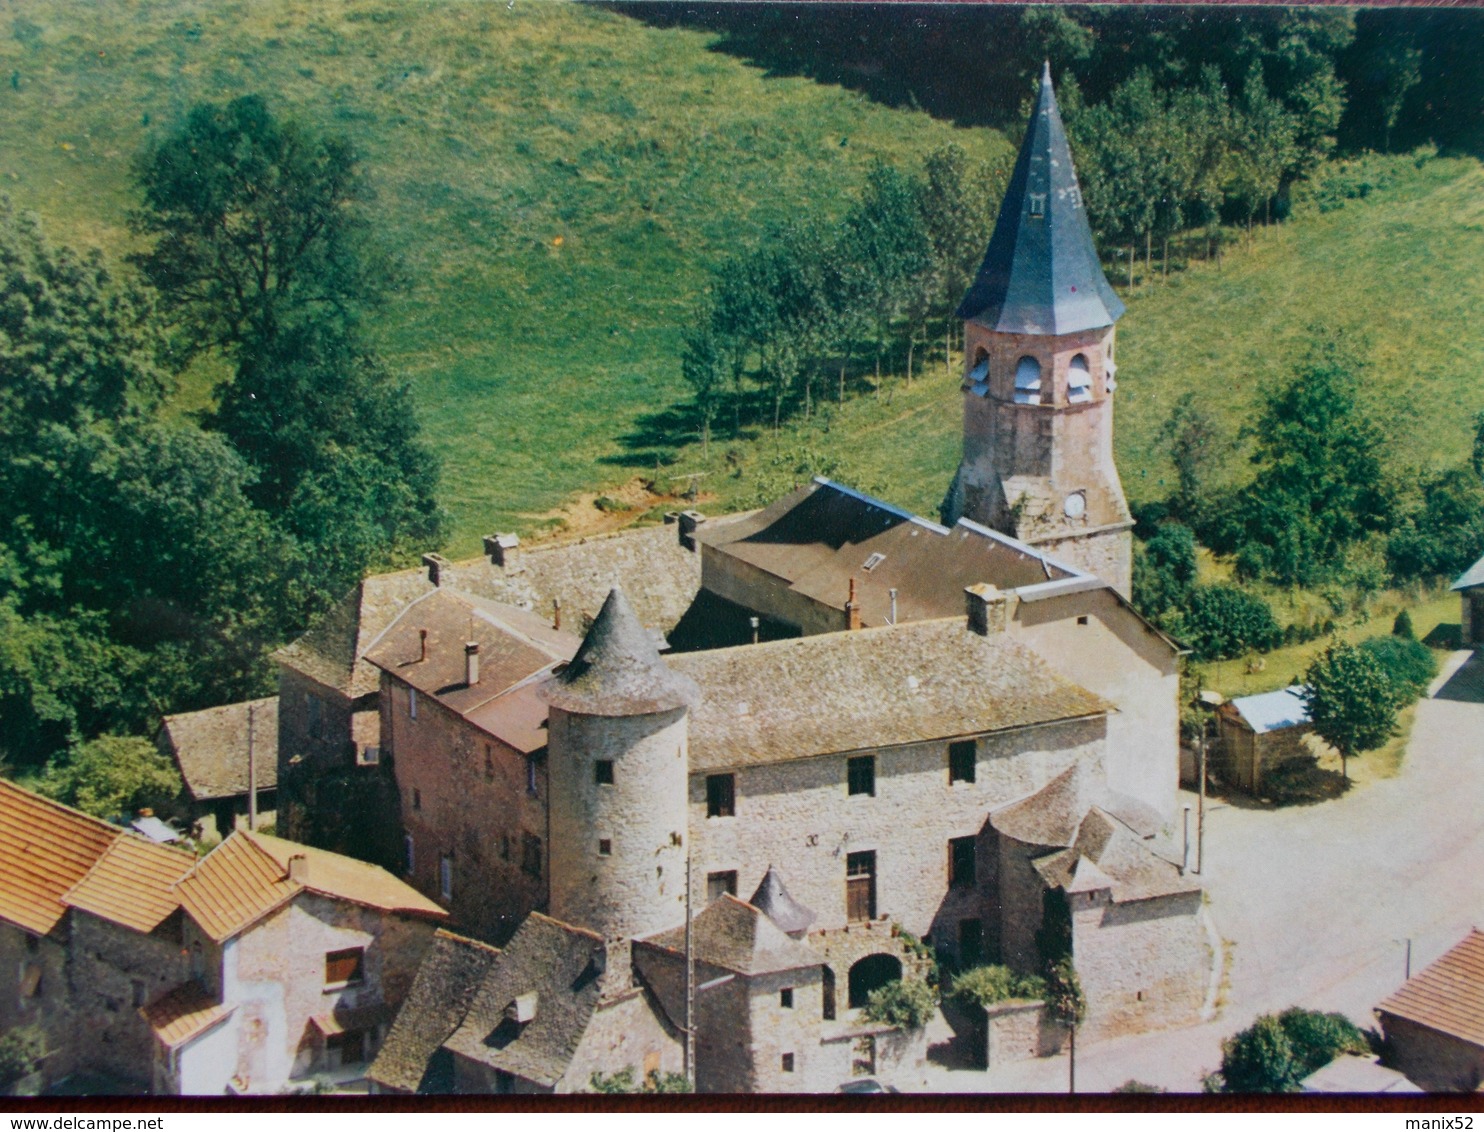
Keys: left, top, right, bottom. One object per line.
{"left": 162, "top": 696, "right": 278, "bottom": 801}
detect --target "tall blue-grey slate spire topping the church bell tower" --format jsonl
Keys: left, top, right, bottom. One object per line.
{"left": 959, "top": 62, "right": 1123, "bottom": 334}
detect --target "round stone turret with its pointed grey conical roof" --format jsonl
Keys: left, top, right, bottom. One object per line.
{"left": 543, "top": 589, "right": 700, "bottom": 939}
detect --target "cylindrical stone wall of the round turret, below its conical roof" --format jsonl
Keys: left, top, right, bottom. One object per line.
{"left": 548, "top": 706, "right": 689, "bottom": 939}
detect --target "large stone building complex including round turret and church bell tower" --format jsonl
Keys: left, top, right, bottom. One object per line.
{"left": 243, "top": 74, "right": 1209, "bottom": 1092}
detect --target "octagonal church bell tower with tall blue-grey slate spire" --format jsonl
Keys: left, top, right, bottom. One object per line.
{"left": 945, "top": 64, "right": 1134, "bottom": 596}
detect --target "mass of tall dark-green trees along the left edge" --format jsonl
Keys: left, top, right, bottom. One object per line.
{"left": 0, "top": 96, "right": 442, "bottom": 777}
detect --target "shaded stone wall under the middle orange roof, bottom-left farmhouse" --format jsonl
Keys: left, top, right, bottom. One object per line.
{"left": 71, "top": 909, "right": 190, "bottom": 1085}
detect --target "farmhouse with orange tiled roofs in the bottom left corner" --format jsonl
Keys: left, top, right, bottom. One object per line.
{"left": 0, "top": 780, "right": 447, "bottom": 1095}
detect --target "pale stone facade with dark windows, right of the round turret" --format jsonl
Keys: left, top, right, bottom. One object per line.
{"left": 677, "top": 718, "right": 1106, "bottom": 950}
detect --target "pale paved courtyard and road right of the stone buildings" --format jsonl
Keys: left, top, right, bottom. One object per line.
{"left": 923, "top": 653, "right": 1484, "bottom": 1092}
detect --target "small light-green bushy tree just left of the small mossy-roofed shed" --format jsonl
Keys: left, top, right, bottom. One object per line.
{"left": 39, "top": 734, "right": 184, "bottom": 819}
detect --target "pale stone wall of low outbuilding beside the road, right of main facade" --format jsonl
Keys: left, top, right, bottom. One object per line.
{"left": 1067, "top": 892, "right": 1212, "bottom": 1041}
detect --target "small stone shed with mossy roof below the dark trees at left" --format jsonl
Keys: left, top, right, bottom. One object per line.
{"left": 156, "top": 696, "right": 278, "bottom": 840}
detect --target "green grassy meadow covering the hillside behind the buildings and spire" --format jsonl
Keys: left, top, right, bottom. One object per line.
{"left": 0, "top": 0, "right": 1484, "bottom": 555}
